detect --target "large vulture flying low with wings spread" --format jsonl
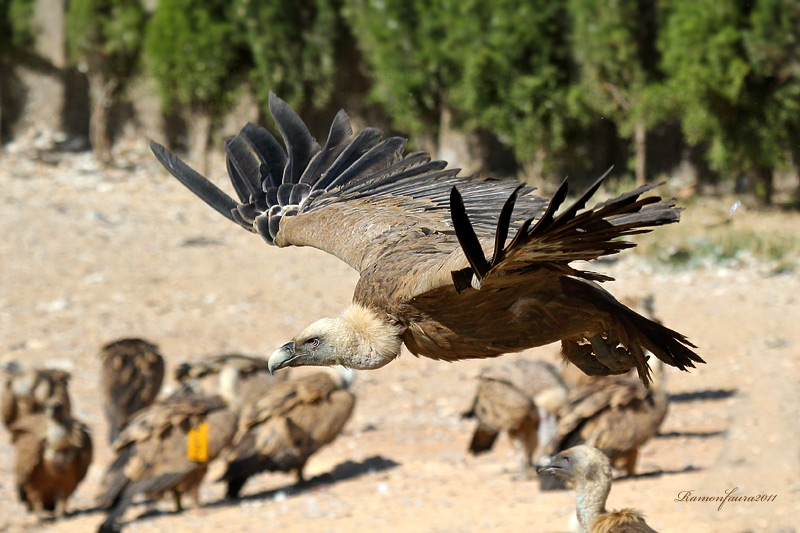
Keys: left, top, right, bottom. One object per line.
{"left": 150, "top": 94, "right": 703, "bottom": 382}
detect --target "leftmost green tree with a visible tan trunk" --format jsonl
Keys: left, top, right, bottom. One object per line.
{"left": 67, "top": 0, "right": 145, "bottom": 164}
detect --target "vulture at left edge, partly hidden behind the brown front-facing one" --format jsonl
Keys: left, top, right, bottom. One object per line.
{"left": 0, "top": 361, "right": 71, "bottom": 428}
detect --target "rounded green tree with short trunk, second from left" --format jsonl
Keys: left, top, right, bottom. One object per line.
{"left": 145, "top": 0, "right": 244, "bottom": 169}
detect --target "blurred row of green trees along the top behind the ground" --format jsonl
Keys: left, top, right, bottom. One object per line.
{"left": 0, "top": 0, "right": 800, "bottom": 205}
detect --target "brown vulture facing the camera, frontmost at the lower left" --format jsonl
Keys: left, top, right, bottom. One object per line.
{"left": 10, "top": 398, "right": 92, "bottom": 518}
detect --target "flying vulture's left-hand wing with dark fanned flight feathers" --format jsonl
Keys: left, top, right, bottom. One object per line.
{"left": 151, "top": 91, "right": 546, "bottom": 271}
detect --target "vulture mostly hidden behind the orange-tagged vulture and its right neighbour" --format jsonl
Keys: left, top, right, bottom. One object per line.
{"left": 175, "top": 354, "right": 289, "bottom": 411}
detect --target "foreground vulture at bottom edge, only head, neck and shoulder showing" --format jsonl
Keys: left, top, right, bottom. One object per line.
{"left": 536, "top": 445, "right": 656, "bottom": 533}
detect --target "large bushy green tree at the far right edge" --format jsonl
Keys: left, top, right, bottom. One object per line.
{"left": 660, "top": 0, "right": 800, "bottom": 203}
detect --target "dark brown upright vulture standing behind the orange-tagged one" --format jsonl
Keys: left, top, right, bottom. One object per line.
{"left": 100, "top": 339, "right": 164, "bottom": 442}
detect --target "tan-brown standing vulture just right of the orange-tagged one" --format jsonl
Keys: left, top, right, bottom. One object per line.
{"left": 220, "top": 367, "right": 356, "bottom": 498}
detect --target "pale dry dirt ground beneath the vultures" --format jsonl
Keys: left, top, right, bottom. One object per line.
{"left": 0, "top": 143, "right": 800, "bottom": 533}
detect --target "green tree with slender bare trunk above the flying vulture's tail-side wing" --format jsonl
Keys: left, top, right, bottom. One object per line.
{"left": 568, "top": 0, "right": 664, "bottom": 185}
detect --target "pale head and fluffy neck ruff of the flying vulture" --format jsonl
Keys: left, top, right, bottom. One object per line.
{"left": 269, "top": 304, "right": 401, "bottom": 372}
